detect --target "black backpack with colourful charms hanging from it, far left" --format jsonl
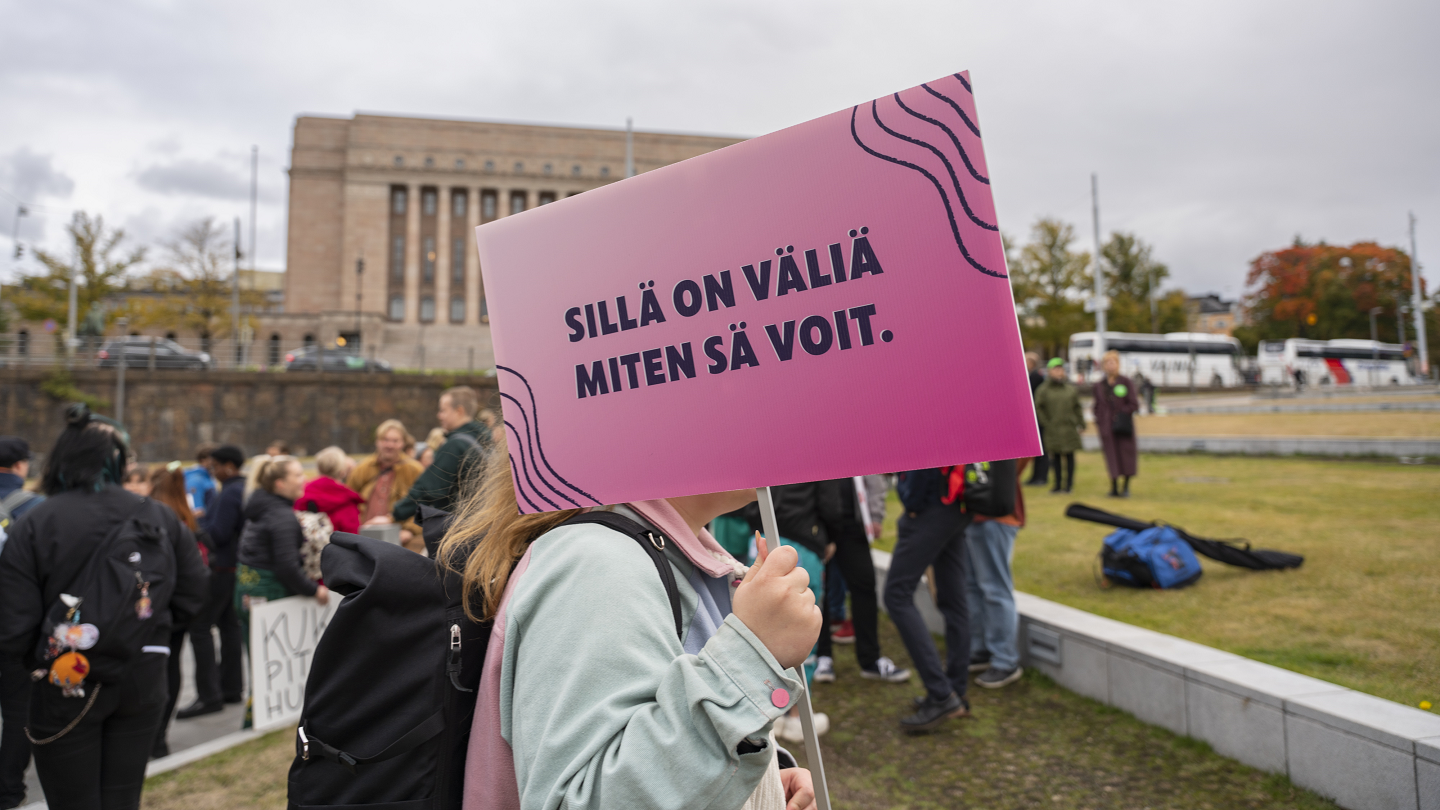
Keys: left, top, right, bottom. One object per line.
{"left": 35, "top": 499, "right": 176, "bottom": 689}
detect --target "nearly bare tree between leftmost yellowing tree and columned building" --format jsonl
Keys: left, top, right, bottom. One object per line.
{"left": 128, "top": 218, "right": 265, "bottom": 349}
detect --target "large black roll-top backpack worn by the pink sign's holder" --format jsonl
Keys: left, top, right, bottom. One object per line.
{"left": 289, "top": 507, "right": 683, "bottom": 810}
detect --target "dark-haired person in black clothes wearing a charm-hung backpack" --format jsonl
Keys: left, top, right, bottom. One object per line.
{"left": 0, "top": 405, "right": 209, "bottom": 810}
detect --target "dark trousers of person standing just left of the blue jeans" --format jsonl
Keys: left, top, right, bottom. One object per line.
{"left": 884, "top": 503, "right": 971, "bottom": 700}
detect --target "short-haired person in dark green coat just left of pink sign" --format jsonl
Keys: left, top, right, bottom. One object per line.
{"left": 392, "top": 385, "right": 491, "bottom": 523}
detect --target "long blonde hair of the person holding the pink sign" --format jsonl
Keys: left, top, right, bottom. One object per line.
{"left": 436, "top": 438, "right": 582, "bottom": 621}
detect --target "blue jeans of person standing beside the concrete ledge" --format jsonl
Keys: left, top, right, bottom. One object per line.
{"left": 965, "top": 520, "right": 1020, "bottom": 670}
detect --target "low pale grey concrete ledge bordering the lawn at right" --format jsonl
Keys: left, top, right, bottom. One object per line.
{"left": 871, "top": 552, "right": 1440, "bottom": 810}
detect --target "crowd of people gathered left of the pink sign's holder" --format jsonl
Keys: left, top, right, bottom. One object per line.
{"left": 0, "top": 386, "right": 494, "bottom": 810}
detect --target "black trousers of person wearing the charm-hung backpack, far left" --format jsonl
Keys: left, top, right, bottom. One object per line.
{"left": 30, "top": 653, "right": 168, "bottom": 810}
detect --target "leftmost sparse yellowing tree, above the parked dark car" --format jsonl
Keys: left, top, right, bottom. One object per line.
{"left": 7, "top": 210, "right": 145, "bottom": 336}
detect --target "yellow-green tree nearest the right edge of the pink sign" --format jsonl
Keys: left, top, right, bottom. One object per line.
{"left": 1009, "top": 218, "right": 1093, "bottom": 356}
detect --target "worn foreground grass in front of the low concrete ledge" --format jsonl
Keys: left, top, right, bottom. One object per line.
{"left": 788, "top": 621, "right": 1335, "bottom": 810}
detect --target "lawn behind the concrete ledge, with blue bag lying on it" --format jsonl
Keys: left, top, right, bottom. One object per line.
{"left": 877, "top": 453, "right": 1440, "bottom": 706}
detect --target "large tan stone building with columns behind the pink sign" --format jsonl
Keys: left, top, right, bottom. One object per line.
{"left": 277, "top": 114, "right": 739, "bottom": 369}
